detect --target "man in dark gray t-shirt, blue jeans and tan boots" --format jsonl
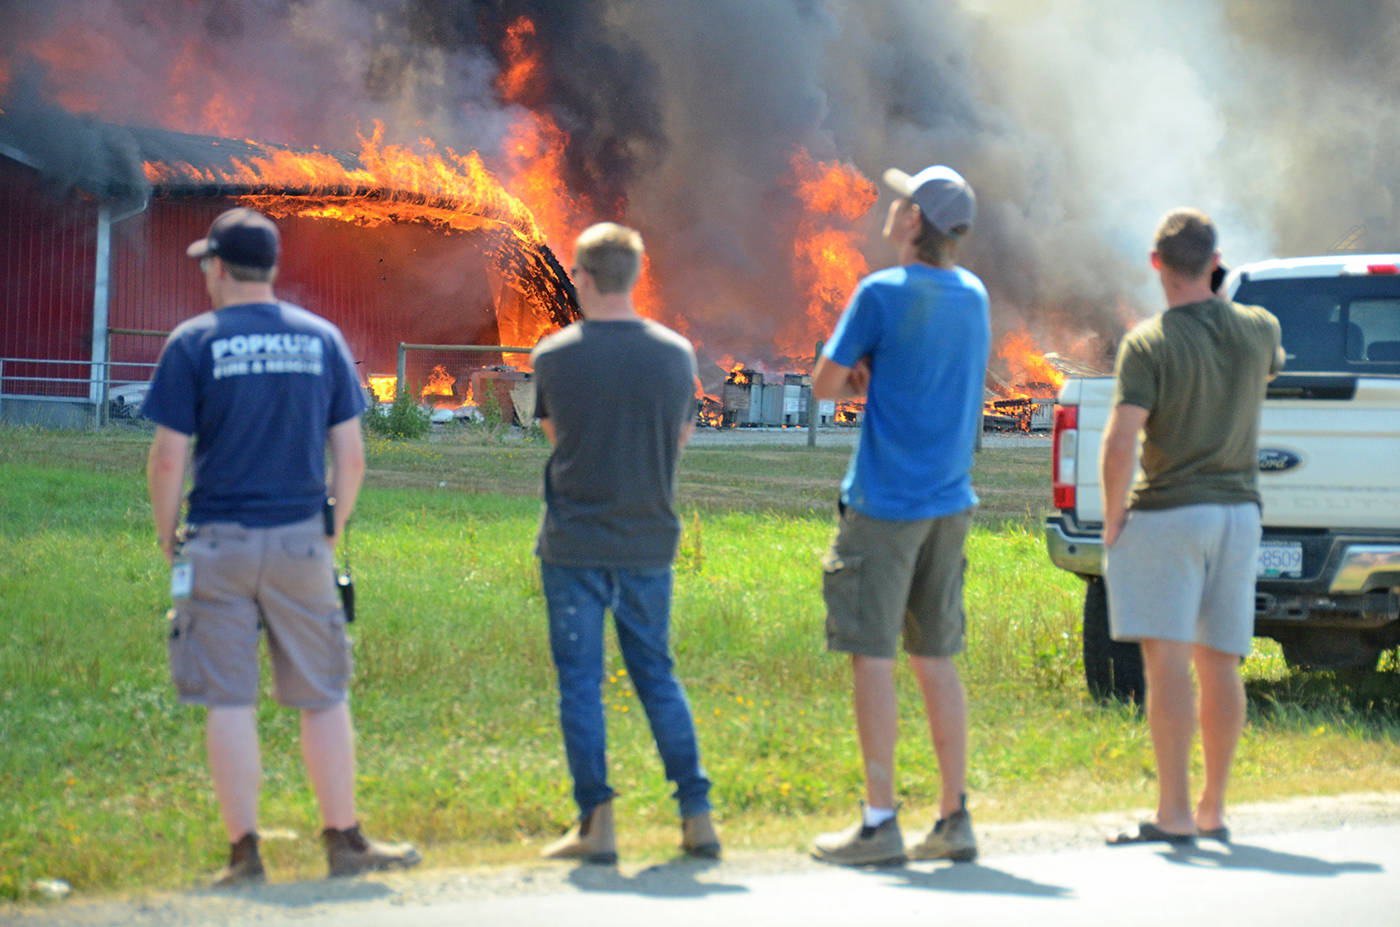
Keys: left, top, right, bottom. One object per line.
{"left": 531, "top": 223, "right": 720, "bottom": 863}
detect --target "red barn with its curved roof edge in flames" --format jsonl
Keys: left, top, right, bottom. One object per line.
{"left": 0, "top": 112, "right": 577, "bottom": 426}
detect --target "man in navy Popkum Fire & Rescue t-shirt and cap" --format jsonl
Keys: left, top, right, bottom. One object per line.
{"left": 141, "top": 209, "right": 420, "bottom": 885}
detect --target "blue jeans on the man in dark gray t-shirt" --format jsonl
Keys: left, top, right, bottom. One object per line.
{"left": 540, "top": 563, "right": 710, "bottom": 818}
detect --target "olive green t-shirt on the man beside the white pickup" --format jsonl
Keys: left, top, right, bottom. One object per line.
{"left": 1113, "top": 300, "right": 1282, "bottom": 508}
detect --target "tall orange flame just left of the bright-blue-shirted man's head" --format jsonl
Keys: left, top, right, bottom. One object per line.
{"left": 778, "top": 147, "right": 879, "bottom": 357}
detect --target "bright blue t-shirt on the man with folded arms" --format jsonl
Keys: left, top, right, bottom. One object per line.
{"left": 822, "top": 263, "right": 991, "bottom": 521}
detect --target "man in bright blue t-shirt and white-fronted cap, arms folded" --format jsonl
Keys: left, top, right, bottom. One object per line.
{"left": 812, "top": 165, "right": 991, "bottom": 865}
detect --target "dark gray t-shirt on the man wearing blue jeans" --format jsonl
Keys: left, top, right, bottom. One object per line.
{"left": 531, "top": 319, "right": 696, "bottom": 570}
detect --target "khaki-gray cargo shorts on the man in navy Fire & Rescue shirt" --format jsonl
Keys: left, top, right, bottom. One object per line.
{"left": 169, "top": 514, "right": 350, "bottom": 709}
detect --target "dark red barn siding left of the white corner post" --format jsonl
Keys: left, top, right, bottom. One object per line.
{"left": 0, "top": 158, "right": 98, "bottom": 398}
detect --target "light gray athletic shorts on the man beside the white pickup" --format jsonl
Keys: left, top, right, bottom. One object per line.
{"left": 1105, "top": 503, "right": 1260, "bottom": 657}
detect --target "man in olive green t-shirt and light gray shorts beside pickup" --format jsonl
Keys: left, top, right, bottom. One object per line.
{"left": 1099, "top": 209, "right": 1282, "bottom": 844}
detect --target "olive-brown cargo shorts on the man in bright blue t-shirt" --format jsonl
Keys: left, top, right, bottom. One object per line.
{"left": 822, "top": 507, "right": 973, "bottom": 658}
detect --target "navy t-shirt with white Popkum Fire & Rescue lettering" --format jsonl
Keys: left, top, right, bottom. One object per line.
{"left": 141, "top": 302, "right": 367, "bottom": 528}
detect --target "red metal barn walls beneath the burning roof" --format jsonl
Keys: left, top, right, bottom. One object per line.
{"left": 0, "top": 158, "right": 515, "bottom": 411}
